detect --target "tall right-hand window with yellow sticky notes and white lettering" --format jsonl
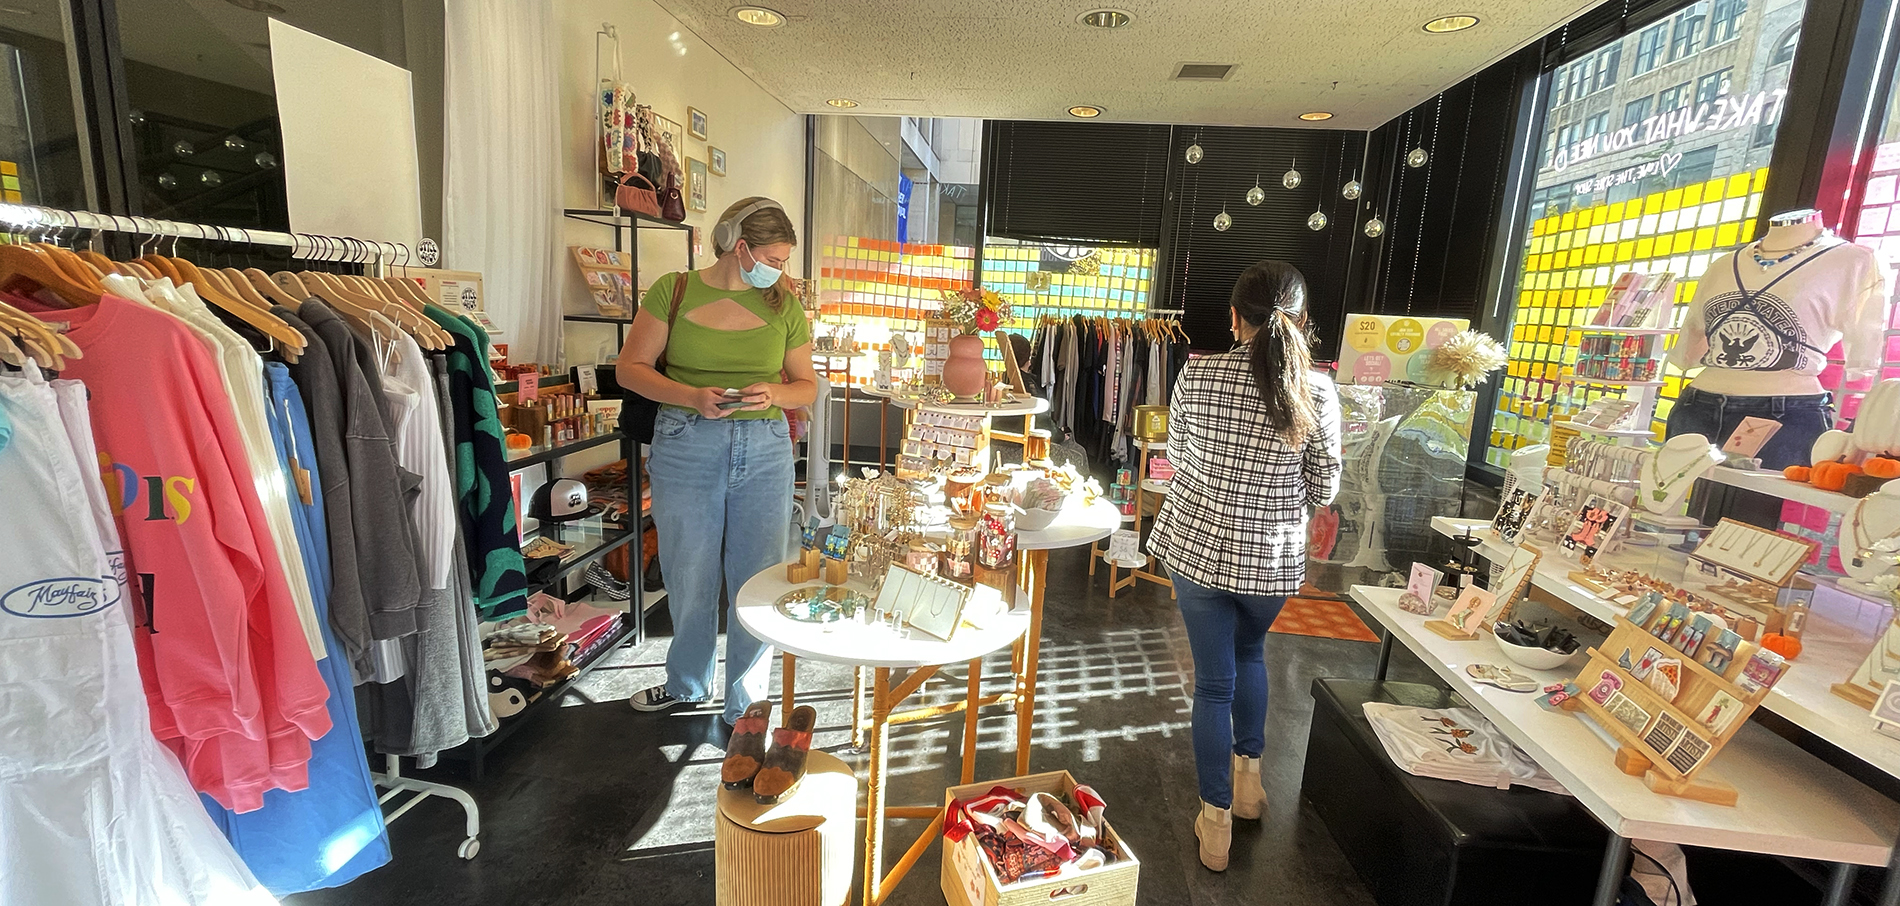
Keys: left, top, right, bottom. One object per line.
{"left": 1486, "top": 0, "right": 1808, "bottom": 467}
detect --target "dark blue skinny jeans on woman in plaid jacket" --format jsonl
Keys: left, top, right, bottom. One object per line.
{"left": 1174, "top": 574, "right": 1286, "bottom": 809}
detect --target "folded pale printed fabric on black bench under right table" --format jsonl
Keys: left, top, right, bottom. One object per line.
{"left": 1366, "top": 701, "right": 1569, "bottom": 796}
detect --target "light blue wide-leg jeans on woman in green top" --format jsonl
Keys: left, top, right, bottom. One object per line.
{"left": 646, "top": 406, "right": 794, "bottom": 724}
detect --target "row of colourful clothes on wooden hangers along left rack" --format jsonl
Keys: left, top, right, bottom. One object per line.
{"left": 0, "top": 227, "right": 526, "bottom": 904}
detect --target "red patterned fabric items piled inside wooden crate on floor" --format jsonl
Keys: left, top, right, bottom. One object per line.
{"left": 944, "top": 786, "right": 1123, "bottom": 885}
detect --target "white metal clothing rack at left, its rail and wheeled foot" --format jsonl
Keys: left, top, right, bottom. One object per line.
{"left": 0, "top": 205, "right": 481, "bottom": 859}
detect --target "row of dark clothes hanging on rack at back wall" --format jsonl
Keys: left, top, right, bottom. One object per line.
{"left": 1030, "top": 315, "right": 1188, "bottom": 467}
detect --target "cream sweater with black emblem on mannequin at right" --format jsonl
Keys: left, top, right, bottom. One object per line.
{"left": 1668, "top": 241, "right": 1887, "bottom": 397}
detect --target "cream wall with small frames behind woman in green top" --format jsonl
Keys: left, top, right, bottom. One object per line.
{"left": 555, "top": 0, "right": 806, "bottom": 365}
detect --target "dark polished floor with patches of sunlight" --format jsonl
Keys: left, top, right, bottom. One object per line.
{"left": 289, "top": 551, "right": 1429, "bottom": 906}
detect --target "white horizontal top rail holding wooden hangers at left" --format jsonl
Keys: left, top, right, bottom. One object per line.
{"left": 0, "top": 205, "right": 414, "bottom": 266}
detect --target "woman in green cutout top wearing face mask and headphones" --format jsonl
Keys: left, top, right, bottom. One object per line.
{"left": 616, "top": 198, "right": 817, "bottom": 724}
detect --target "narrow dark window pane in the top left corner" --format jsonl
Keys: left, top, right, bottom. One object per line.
{"left": 0, "top": 7, "right": 87, "bottom": 207}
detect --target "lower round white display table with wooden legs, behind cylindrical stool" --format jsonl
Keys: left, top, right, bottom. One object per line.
{"left": 733, "top": 564, "right": 1036, "bottom": 902}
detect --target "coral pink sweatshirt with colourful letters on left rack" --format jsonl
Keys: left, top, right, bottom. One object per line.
{"left": 15, "top": 296, "right": 331, "bottom": 811}
